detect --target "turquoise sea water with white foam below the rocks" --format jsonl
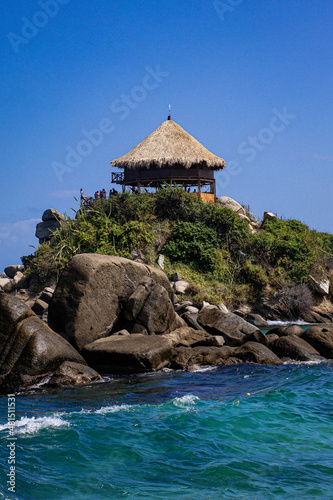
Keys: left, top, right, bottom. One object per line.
{"left": 0, "top": 362, "right": 333, "bottom": 500}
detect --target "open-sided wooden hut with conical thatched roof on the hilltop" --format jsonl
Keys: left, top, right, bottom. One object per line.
{"left": 111, "top": 115, "right": 226, "bottom": 201}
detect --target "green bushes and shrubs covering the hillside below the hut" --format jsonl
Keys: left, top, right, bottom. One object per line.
{"left": 22, "top": 187, "right": 333, "bottom": 307}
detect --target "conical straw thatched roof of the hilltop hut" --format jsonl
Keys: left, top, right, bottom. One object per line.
{"left": 111, "top": 120, "right": 226, "bottom": 170}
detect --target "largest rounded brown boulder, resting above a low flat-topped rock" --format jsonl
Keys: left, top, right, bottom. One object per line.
{"left": 49, "top": 254, "right": 176, "bottom": 349}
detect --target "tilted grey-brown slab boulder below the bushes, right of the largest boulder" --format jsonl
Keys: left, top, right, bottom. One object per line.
{"left": 198, "top": 307, "right": 258, "bottom": 347}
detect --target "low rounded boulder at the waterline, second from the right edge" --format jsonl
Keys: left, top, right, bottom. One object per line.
{"left": 269, "top": 335, "right": 323, "bottom": 361}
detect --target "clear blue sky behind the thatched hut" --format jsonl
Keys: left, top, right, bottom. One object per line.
{"left": 0, "top": 0, "right": 333, "bottom": 272}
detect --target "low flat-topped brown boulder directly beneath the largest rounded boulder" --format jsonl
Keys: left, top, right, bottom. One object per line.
{"left": 82, "top": 334, "right": 173, "bottom": 373}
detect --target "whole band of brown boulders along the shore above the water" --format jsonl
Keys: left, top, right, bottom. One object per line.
{"left": 0, "top": 254, "right": 333, "bottom": 394}
